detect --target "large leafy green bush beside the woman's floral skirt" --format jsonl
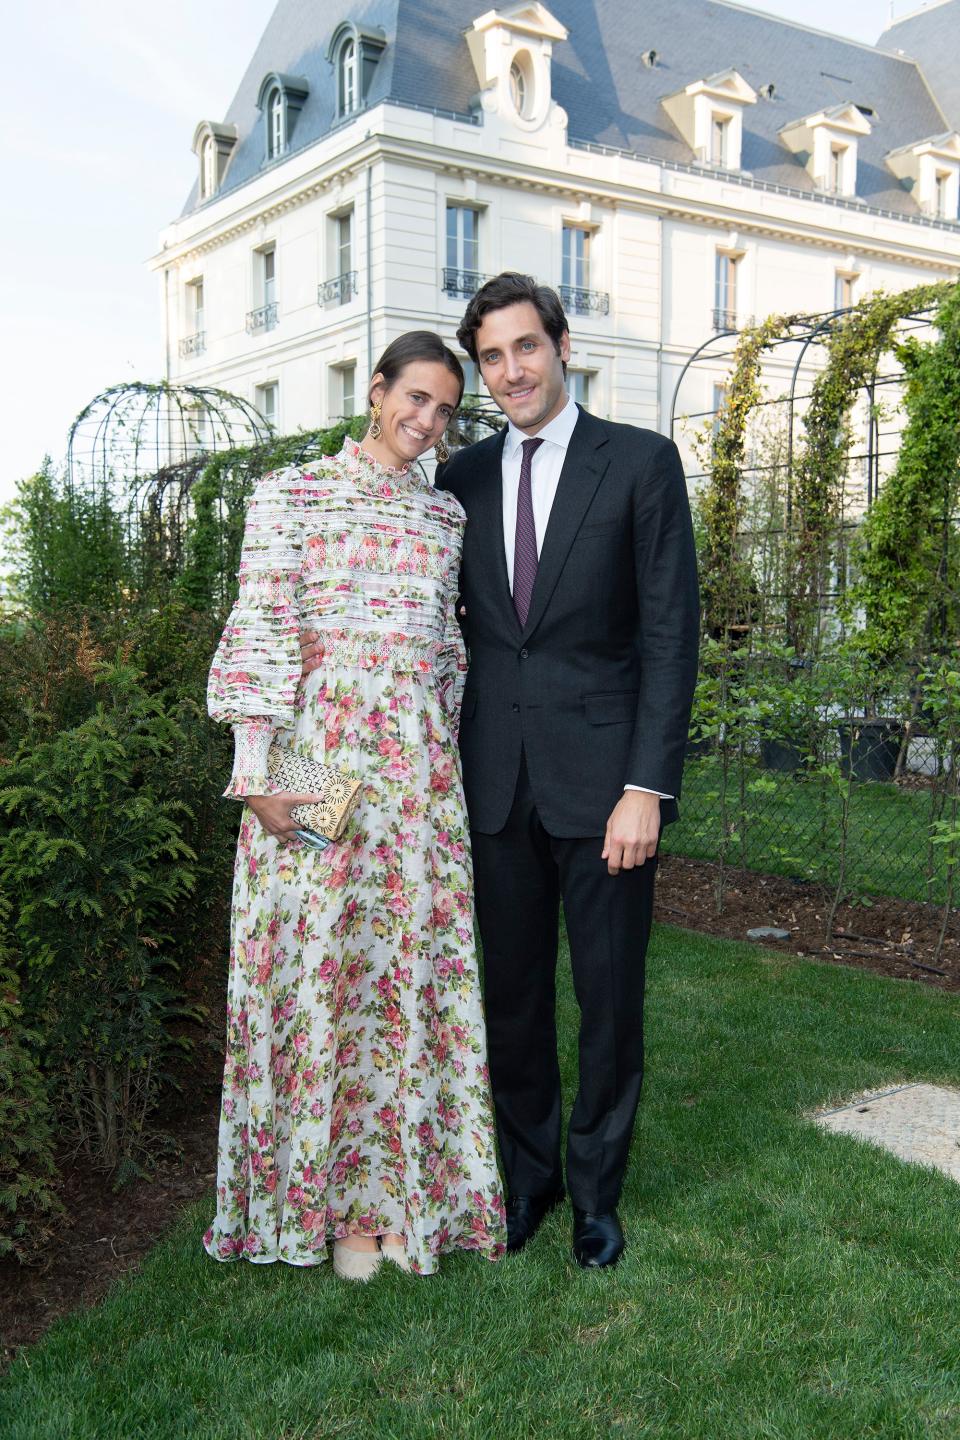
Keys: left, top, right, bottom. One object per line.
{"left": 0, "top": 665, "right": 196, "bottom": 1178}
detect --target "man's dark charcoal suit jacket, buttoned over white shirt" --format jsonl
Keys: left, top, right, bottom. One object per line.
{"left": 436, "top": 410, "right": 699, "bottom": 837}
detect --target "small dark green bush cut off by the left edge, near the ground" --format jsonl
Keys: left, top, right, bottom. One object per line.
{"left": 0, "top": 904, "right": 63, "bottom": 1263}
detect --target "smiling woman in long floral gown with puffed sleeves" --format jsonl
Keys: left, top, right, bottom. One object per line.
{"left": 204, "top": 331, "right": 505, "bottom": 1279}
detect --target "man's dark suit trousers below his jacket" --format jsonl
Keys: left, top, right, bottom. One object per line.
{"left": 471, "top": 759, "right": 656, "bottom": 1212}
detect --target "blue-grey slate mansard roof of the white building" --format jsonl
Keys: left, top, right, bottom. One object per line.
{"left": 186, "top": 0, "right": 960, "bottom": 216}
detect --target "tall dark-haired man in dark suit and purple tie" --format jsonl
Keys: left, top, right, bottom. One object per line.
{"left": 438, "top": 272, "right": 698, "bottom": 1267}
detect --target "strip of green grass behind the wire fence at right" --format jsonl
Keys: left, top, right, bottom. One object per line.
{"left": 664, "top": 757, "right": 947, "bottom": 904}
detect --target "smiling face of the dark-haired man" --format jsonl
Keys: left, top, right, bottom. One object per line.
{"left": 476, "top": 300, "right": 570, "bottom": 435}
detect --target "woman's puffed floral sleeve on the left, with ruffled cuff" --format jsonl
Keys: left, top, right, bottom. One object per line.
{"left": 207, "top": 468, "right": 304, "bottom": 796}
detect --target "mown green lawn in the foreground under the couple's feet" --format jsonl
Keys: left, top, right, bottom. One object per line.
{"left": 0, "top": 929, "right": 960, "bottom": 1440}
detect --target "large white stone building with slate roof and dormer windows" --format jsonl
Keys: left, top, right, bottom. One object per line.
{"left": 151, "top": 0, "right": 960, "bottom": 460}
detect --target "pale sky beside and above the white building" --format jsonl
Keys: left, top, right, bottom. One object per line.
{"left": 0, "top": 0, "right": 920, "bottom": 501}
